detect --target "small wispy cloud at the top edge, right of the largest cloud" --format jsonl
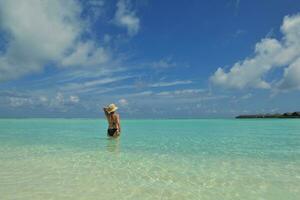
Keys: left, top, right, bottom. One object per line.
{"left": 114, "top": 0, "right": 140, "bottom": 36}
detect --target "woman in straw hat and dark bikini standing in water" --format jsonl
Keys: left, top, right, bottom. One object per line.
{"left": 103, "top": 103, "right": 121, "bottom": 137}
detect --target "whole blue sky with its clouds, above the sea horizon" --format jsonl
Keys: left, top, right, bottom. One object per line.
{"left": 0, "top": 0, "right": 300, "bottom": 118}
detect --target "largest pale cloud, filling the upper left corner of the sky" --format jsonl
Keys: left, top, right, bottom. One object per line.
{"left": 0, "top": 0, "right": 110, "bottom": 81}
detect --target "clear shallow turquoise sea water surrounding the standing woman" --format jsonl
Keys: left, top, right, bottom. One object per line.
{"left": 0, "top": 119, "right": 300, "bottom": 200}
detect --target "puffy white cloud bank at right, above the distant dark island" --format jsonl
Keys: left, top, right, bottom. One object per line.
{"left": 210, "top": 14, "right": 300, "bottom": 90}
